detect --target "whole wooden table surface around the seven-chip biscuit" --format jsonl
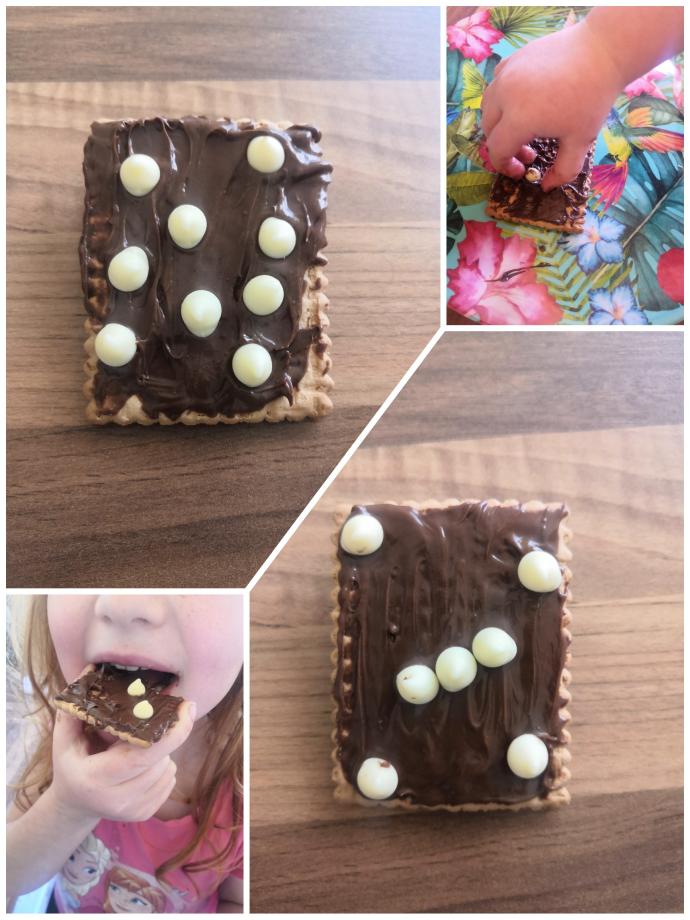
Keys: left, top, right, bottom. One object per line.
{"left": 250, "top": 331, "right": 683, "bottom": 913}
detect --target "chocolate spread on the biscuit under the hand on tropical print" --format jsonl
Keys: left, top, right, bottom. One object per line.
{"left": 486, "top": 138, "right": 594, "bottom": 233}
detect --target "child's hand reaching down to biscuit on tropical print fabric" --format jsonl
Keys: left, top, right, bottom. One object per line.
{"left": 482, "top": 19, "right": 625, "bottom": 191}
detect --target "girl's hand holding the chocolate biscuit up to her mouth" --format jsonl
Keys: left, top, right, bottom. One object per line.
{"left": 51, "top": 702, "right": 196, "bottom": 821}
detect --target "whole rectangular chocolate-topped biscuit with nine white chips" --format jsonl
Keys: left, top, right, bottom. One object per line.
{"left": 79, "top": 116, "right": 333, "bottom": 425}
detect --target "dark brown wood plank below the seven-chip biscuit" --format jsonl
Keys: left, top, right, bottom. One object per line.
{"left": 250, "top": 786, "right": 683, "bottom": 914}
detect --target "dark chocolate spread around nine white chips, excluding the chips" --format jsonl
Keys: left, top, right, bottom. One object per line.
{"left": 79, "top": 116, "right": 332, "bottom": 421}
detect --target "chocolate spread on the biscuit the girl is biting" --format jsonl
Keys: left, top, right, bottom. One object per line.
{"left": 55, "top": 664, "right": 182, "bottom": 746}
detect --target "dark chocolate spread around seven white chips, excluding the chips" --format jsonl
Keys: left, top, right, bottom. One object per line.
{"left": 334, "top": 502, "right": 569, "bottom": 806}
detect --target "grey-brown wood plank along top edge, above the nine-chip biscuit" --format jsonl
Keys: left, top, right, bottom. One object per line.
{"left": 7, "top": 6, "right": 440, "bottom": 83}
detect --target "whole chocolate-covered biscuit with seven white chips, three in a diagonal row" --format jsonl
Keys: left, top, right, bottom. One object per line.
{"left": 333, "top": 501, "right": 570, "bottom": 811}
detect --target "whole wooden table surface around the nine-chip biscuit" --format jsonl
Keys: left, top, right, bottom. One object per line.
{"left": 7, "top": 7, "right": 441, "bottom": 587}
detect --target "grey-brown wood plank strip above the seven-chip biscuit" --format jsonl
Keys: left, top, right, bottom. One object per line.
{"left": 367, "top": 330, "right": 683, "bottom": 446}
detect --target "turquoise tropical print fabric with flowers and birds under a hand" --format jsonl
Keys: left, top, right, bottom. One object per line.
{"left": 447, "top": 7, "right": 683, "bottom": 325}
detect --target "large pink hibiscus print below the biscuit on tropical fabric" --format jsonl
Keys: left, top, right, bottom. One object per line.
{"left": 448, "top": 220, "right": 563, "bottom": 325}
